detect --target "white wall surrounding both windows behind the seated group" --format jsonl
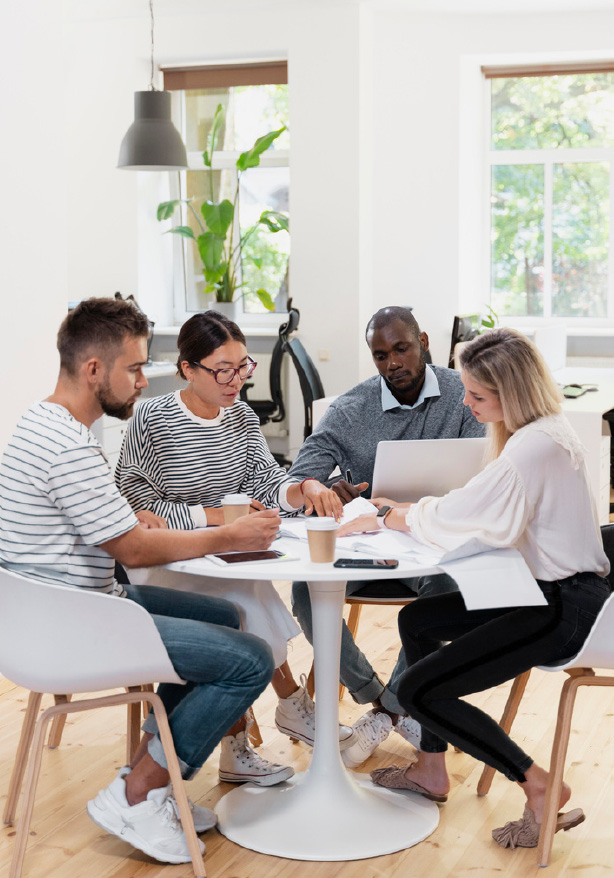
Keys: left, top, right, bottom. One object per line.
{"left": 0, "top": 0, "right": 614, "bottom": 454}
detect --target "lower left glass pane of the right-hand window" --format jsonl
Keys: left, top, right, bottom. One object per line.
{"left": 491, "top": 165, "right": 544, "bottom": 316}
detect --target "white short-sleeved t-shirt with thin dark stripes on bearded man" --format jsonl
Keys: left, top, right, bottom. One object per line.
{"left": 0, "top": 402, "right": 138, "bottom": 595}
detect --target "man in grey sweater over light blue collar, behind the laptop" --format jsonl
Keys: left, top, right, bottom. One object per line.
{"left": 290, "top": 307, "right": 485, "bottom": 767}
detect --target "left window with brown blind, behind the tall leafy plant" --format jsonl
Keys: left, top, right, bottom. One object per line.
{"left": 164, "top": 61, "right": 290, "bottom": 319}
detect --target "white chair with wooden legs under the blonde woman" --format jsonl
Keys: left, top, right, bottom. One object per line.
{"left": 478, "top": 524, "right": 614, "bottom": 866}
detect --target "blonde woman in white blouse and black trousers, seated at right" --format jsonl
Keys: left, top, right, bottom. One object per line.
{"left": 341, "top": 329, "right": 610, "bottom": 847}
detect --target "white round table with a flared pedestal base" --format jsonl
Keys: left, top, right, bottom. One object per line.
{"left": 168, "top": 539, "right": 440, "bottom": 861}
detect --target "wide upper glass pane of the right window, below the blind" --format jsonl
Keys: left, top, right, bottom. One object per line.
{"left": 491, "top": 73, "right": 614, "bottom": 149}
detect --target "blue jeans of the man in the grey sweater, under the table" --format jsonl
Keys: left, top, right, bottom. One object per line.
{"left": 292, "top": 573, "right": 458, "bottom": 715}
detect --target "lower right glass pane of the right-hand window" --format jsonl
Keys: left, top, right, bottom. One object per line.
{"left": 552, "top": 162, "right": 610, "bottom": 317}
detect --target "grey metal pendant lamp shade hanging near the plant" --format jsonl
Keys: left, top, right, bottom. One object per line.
{"left": 117, "top": 91, "right": 188, "bottom": 171}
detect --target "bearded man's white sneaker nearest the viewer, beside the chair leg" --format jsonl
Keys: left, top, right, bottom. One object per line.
{"left": 87, "top": 777, "right": 205, "bottom": 863}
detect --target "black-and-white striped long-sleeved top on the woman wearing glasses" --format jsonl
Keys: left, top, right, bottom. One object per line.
{"left": 115, "top": 390, "right": 295, "bottom": 530}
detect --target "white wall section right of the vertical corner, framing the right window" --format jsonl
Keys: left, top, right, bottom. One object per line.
{"left": 373, "top": 7, "right": 614, "bottom": 363}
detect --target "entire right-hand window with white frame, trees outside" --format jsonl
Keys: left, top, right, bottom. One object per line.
{"left": 482, "top": 63, "right": 614, "bottom": 321}
